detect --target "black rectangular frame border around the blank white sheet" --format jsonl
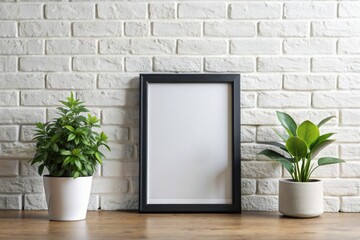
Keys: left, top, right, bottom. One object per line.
{"left": 139, "top": 74, "right": 241, "bottom": 213}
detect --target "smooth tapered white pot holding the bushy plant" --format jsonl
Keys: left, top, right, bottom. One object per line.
{"left": 44, "top": 176, "right": 92, "bottom": 221}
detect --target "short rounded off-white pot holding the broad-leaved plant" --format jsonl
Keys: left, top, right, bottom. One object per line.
{"left": 279, "top": 179, "right": 324, "bottom": 218}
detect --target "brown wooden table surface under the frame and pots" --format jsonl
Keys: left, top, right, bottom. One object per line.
{"left": 0, "top": 211, "right": 360, "bottom": 240}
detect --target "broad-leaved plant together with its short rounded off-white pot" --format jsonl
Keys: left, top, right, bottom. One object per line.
{"left": 259, "top": 112, "right": 344, "bottom": 217}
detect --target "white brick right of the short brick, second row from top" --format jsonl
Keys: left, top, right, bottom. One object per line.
{"left": 152, "top": 22, "right": 201, "bottom": 37}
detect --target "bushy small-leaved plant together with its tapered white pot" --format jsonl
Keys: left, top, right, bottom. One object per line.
{"left": 30, "top": 92, "right": 110, "bottom": 221}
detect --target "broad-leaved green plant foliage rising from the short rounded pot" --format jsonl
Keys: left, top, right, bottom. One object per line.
{"left": 259, "top": 112, "right": 345, "bottom": 182}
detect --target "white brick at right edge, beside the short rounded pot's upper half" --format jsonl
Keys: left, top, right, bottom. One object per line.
{"left": 323, "top": 179, "right": 360, "bottom": 196}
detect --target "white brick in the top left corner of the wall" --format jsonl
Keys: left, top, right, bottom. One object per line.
{"left": 0, "top": 4, "right": 42, "bottom": 20}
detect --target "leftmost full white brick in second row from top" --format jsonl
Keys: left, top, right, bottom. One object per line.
{"left": 19, "top": 22, "right": 70, "bottom": 37}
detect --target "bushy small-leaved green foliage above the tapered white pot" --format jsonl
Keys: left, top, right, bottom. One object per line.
{"left": 30, "top": 92, "right": 110, "bottom": 178}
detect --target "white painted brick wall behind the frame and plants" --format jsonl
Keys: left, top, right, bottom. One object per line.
{"left": 0, "top": 0, "right": 360, "bottom": 212}
